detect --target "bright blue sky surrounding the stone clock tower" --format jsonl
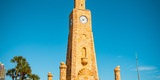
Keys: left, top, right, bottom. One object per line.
{"left": 0, "top": 0, "right": 160, "bottom": 80}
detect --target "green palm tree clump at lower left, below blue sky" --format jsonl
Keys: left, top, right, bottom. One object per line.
{"left": 6, "top": 56, "right": 40, "bottom": 80}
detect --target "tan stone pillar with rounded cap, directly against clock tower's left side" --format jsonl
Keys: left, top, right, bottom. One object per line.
{"left": 59, "top": 62, "right": 67, "bottom": 80}
